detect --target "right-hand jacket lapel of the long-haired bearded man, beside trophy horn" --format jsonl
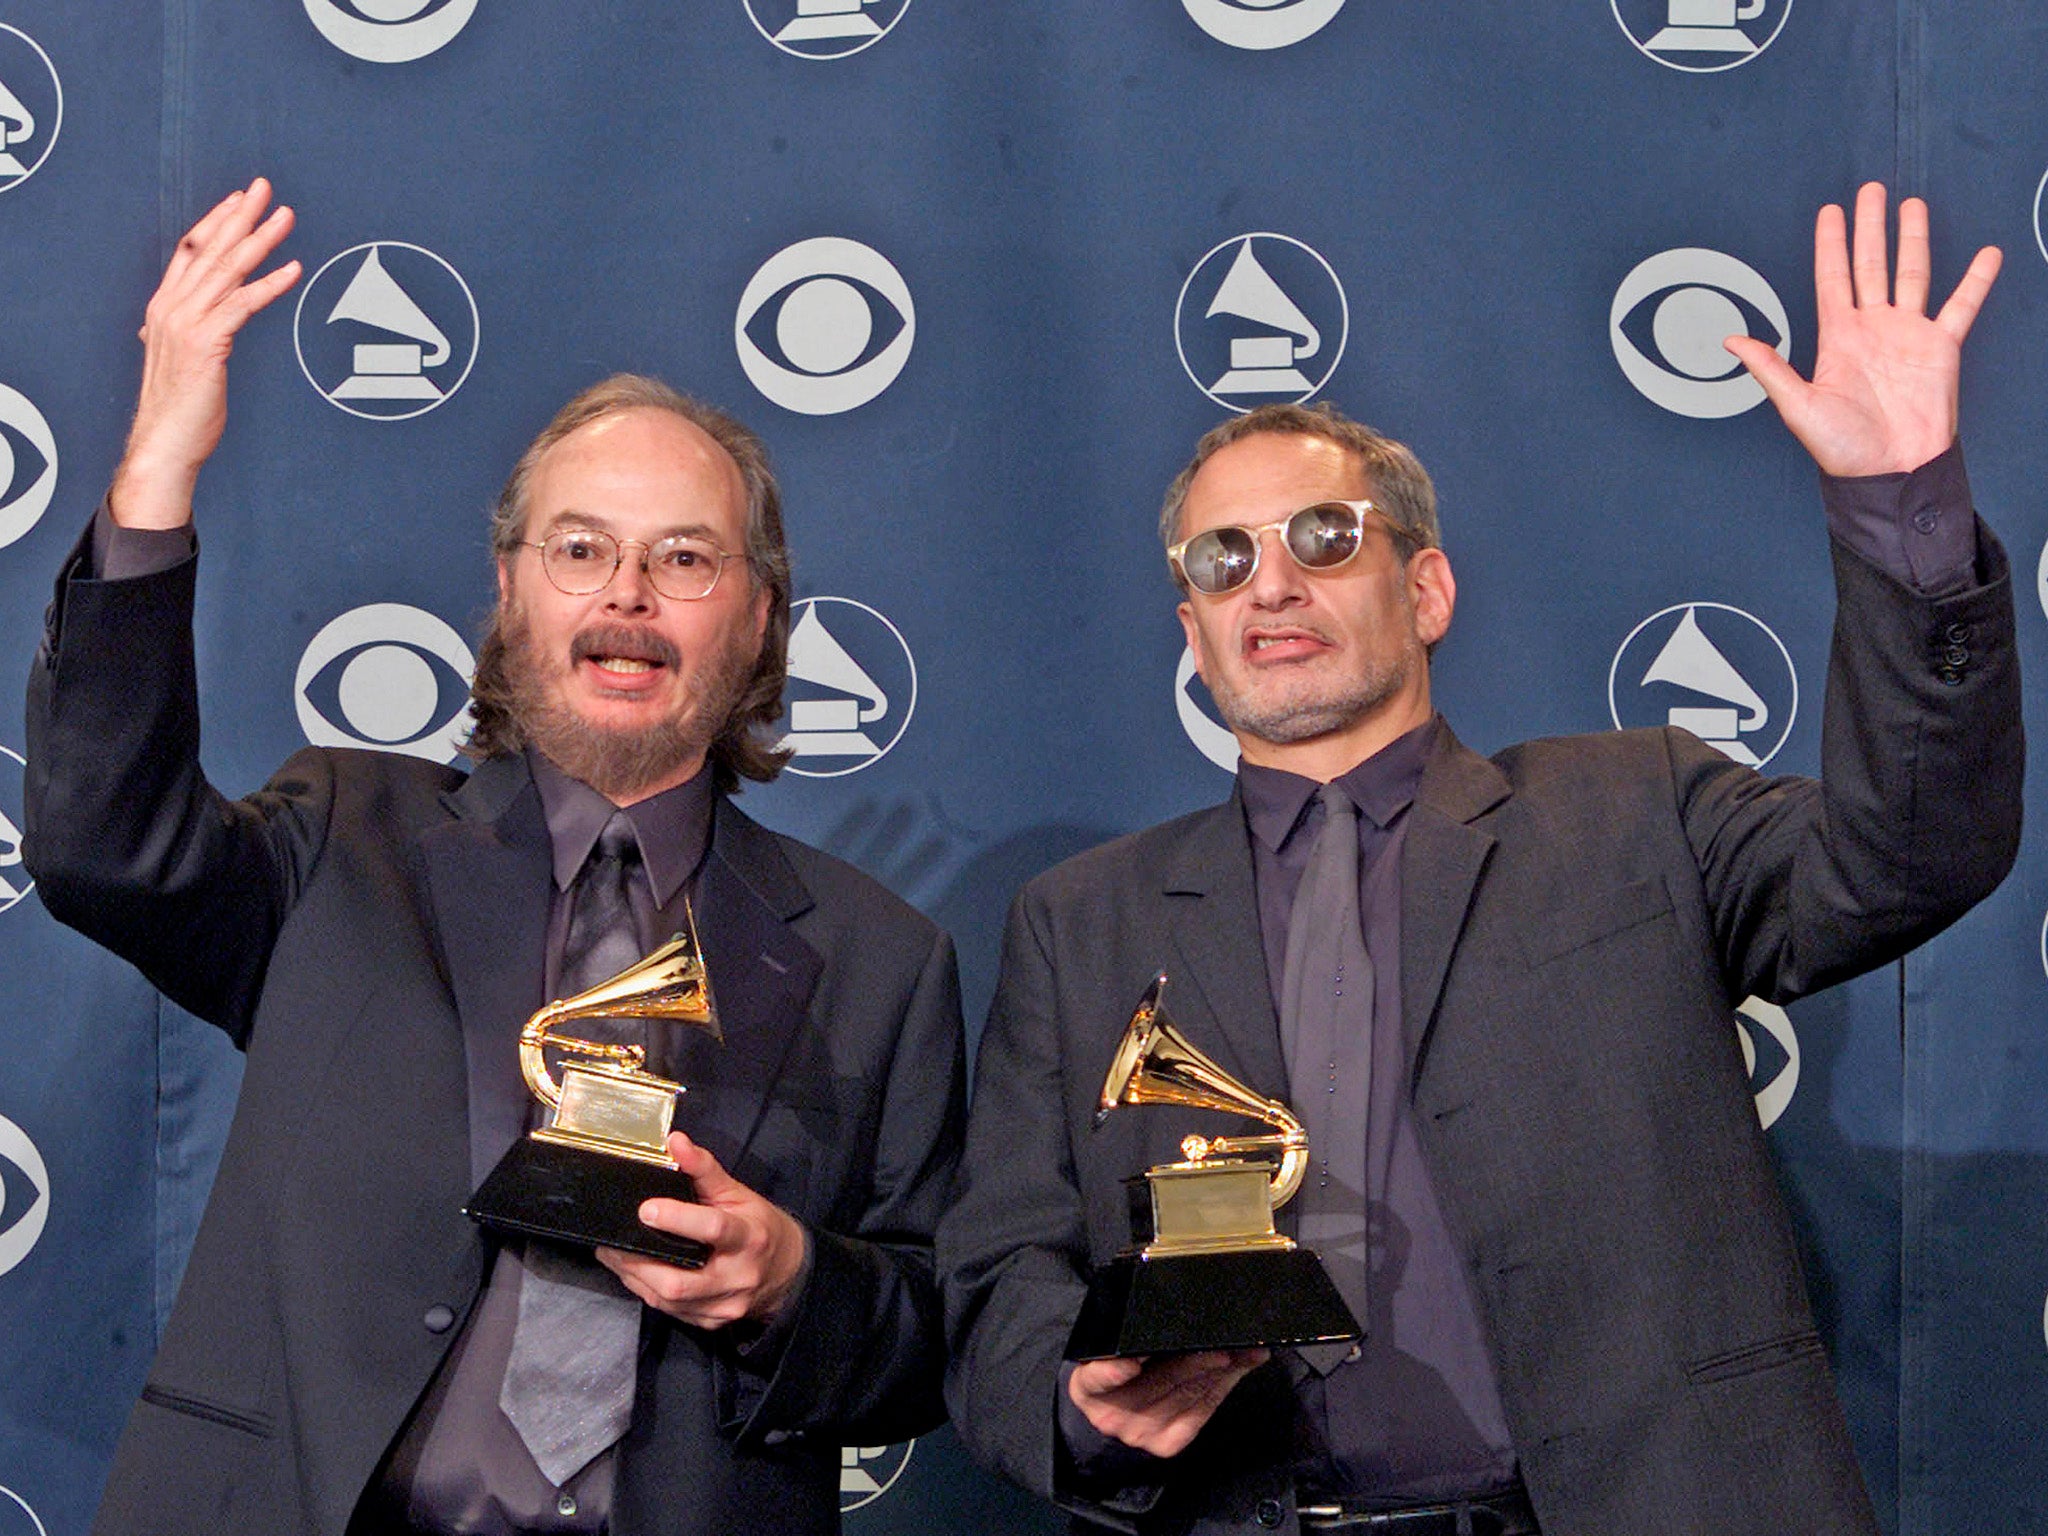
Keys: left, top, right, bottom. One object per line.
{"left": 678, "top": 799, "right": 823, "bottom": 1171}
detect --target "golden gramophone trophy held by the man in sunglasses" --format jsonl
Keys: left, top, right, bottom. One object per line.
{"left": 1067, "top": 971, "right": 1360, "bottom": 1360}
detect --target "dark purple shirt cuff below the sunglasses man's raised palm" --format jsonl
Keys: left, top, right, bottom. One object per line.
{"left": 1821, "top": 442, "right": 1978, "bottom": 598}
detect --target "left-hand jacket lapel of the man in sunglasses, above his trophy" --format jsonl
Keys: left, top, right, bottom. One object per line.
{"left": 1163, "top": 793, "right": 1286, "bottom": 1098}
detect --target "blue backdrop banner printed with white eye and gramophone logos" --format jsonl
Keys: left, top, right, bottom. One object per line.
{"left": 0, "top": 0, "right": 2048, "bottom": 1536}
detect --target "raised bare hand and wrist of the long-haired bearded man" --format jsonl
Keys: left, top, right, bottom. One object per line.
{"left": 109, "top": 176, "right": 299, "bottom": 528}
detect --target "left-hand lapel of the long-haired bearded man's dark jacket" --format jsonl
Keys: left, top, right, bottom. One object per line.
{"left": 420, "top": 756, "right": 553, "bottom": 1186}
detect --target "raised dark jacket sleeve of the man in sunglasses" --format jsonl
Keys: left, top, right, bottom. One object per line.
{"left": 1667, "top": 528, "right": 2025, "bottom": 1001}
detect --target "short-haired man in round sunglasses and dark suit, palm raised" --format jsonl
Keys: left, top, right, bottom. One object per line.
{"left": 940, "top": 184, "right": 2023, "bottom": 1536}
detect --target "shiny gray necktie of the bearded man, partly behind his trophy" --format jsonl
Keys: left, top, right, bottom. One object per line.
{"left": 498, "top": 811, "right": 641, "bottom": 1487}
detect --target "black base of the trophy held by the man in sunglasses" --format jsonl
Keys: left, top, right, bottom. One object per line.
{"left": 1067, "top": 1247, "right": 1362, "bottom": 1360}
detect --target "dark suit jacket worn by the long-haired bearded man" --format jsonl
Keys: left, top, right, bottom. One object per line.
{"left": 25, "top": 532, "right": 963, "bottom": 1536}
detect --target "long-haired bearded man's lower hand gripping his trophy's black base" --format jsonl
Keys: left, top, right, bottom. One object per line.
{"left": 598, "top": 1130, "right": 805, "bottom": 1327}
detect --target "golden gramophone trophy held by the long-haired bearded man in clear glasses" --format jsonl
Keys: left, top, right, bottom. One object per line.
{"left": 463, "top": 909, "right": 723, "bottom": 1268}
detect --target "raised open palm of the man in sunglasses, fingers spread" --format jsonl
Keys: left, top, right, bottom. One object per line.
{"left": 1724, "top": 182, "right": 2003, "bottom": 475}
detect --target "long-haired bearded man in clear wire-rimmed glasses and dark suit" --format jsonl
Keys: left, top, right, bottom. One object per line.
{"left": 27, "top": 180, "right": 965, "bottom": 1536}
